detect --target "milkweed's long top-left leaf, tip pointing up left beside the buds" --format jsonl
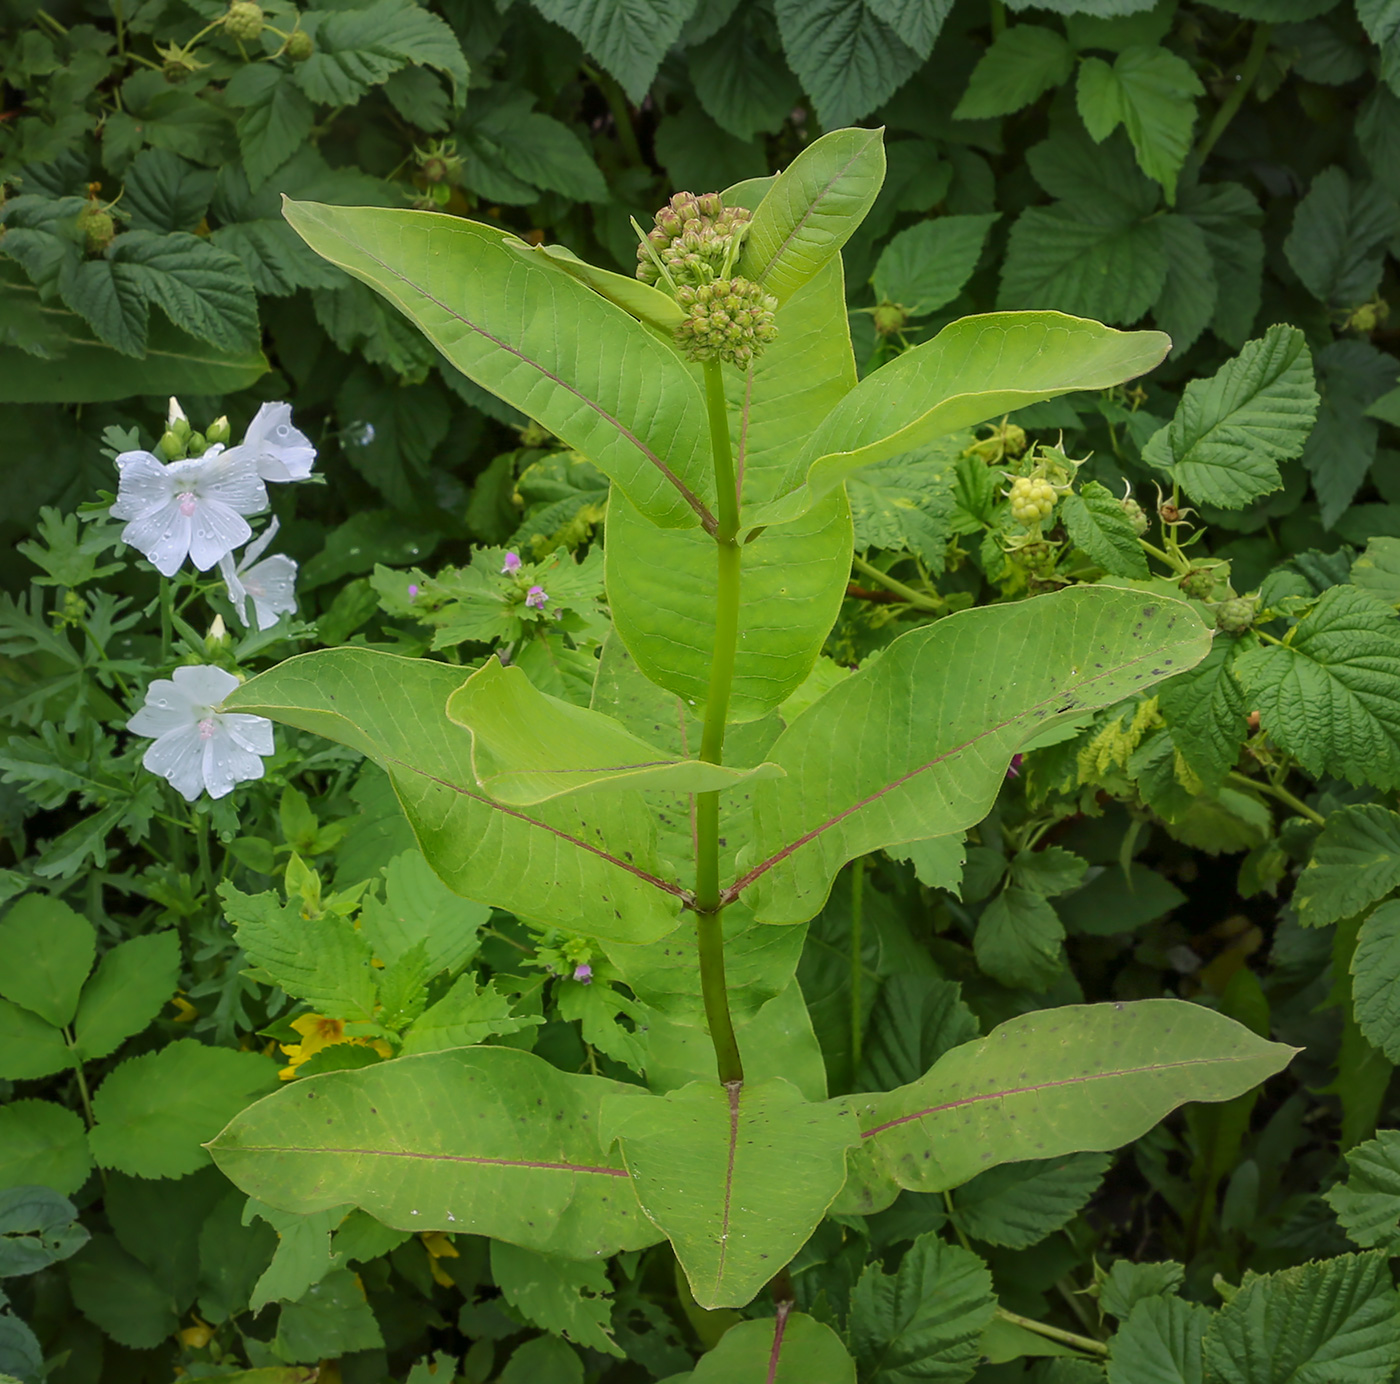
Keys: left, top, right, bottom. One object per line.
{"left": 286, "top": 202, "right": 713, "bottom": 529}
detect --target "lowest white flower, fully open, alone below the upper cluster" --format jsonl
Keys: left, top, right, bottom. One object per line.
{"left": 126, "top": 665, "right": 273, "bottom": 802}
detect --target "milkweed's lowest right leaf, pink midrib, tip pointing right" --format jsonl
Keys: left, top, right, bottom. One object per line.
{"left": 843, "top": 999, "right": 1296, "bottom": 1192}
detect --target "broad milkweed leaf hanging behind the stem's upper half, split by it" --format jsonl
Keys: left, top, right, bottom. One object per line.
{"left": 603, "top": 493, "right": 851, "bottom": 721}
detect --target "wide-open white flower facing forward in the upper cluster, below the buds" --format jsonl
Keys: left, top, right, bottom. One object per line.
{"left": 112, "top": 445, "right": 267, "bottom": 577}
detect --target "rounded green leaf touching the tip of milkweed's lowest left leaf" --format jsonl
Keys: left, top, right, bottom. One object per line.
{"left": 88, "top": 1038, "right": 277, "bottom": 1177}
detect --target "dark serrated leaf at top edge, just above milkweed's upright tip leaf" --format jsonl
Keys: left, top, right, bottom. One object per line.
{"left": 774, "top": 0, "right": 923, "bottom": 132}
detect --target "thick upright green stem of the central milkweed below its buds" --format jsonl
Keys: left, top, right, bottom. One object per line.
{"left": 696, "top": 361, "right": 743, "bottom": 1086}
